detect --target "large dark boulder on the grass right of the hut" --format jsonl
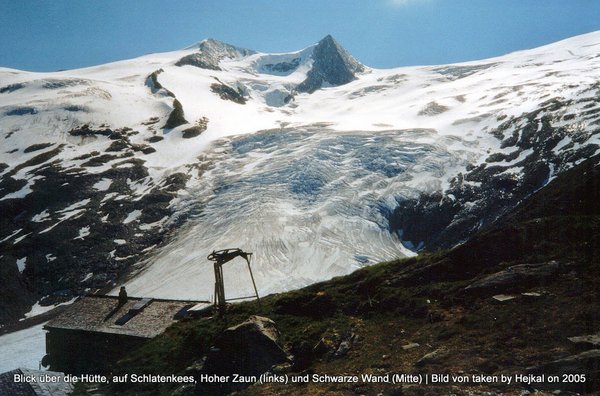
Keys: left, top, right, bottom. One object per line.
{"left": 197, "top": 316, "right": 288, "bottom": 393}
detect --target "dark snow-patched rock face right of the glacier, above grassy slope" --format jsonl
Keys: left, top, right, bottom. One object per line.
{"left": 390, "top": 92, "right": 600, "bottom": 250}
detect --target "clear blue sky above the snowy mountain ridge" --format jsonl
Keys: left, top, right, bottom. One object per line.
{"left": 0, "top": 0, "right": 600, "bottom": 71}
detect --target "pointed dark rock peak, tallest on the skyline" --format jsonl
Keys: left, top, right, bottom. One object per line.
{"left": 296, "top": 35, "right": 365, "bottom": 93}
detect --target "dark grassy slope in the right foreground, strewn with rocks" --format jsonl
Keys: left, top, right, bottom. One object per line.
{"left": 105, "top": 157, "right": 600, "bottom": 395}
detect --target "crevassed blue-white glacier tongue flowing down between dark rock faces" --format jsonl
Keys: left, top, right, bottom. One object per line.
{"left": 127, "top": 126, "right": 465, "bottom": 298}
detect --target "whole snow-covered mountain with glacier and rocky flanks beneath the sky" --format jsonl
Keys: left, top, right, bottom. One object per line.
{"left": 0, "top": 32, "right": 600, "bottom": 319}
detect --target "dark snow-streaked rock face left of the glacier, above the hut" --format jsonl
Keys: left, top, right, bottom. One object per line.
{"left": 0, "top": 125, "right": 187, "bottom": 323}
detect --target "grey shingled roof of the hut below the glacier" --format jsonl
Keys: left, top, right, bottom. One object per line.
{"left": 44, "top": 296, "right": 197, "bottom": 338}
